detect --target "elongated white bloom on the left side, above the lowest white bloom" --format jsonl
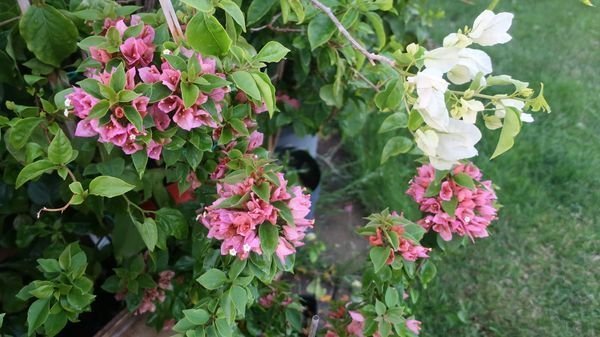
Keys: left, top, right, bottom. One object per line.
{"left": 407, "top": 68, "right": 450, "bottom": 131}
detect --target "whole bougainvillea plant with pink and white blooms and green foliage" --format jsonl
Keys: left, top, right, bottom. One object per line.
{"left": 0, "top": 0, "right": 549, "bottom": 337}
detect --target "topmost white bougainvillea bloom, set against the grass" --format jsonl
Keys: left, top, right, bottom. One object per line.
{"left": 469, "top": 10, "right": 514, "bottom": 46}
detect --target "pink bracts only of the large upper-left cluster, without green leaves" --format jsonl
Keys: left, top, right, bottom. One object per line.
{"left": 65, "top": 15, "right": 229, "bottom": 160}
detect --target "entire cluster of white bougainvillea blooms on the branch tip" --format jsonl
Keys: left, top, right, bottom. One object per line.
{"left": 407, "top": 10, "right": 549, "bottom": 170}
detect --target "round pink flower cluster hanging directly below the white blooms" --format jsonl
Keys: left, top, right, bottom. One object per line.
{"left": 407, "top": 163, "right": 497, "bottom": 241}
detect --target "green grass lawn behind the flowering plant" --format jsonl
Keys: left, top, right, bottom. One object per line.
{"left": 349, "top": 0, "right": 600, "bottom": 337}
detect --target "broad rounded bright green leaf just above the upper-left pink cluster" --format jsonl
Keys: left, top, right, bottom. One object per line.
{"left": 185, "top": 13, "right": 231, "bottom": 56}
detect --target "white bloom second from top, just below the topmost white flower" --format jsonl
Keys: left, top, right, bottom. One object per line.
{"left": 447, "top": 48, "right": 492, "bottom": 84}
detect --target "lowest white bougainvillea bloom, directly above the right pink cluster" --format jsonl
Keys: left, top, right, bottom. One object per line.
{"left": 415, "top": 119, "right": 481, "bottom": 170}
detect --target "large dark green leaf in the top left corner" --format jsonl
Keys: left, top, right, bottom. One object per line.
{"left": 19, "top": 5, "right": 79, "bottom": 67}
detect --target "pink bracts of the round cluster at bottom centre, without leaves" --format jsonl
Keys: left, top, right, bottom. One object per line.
{"left": 199, "top": 173, "right": 314, "bottom": 263}
